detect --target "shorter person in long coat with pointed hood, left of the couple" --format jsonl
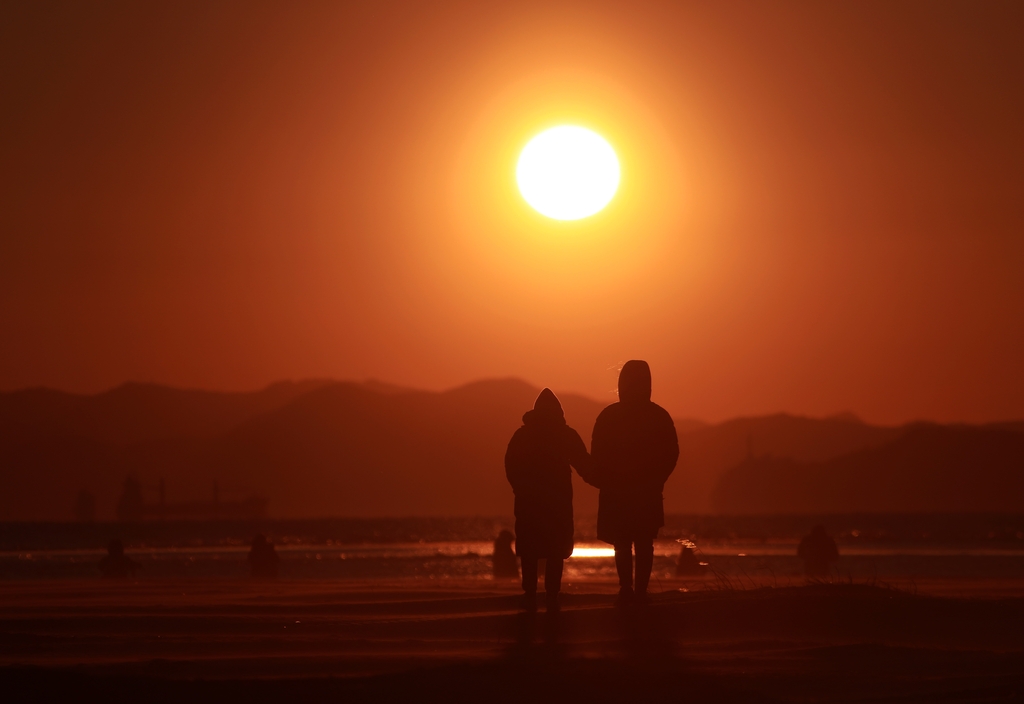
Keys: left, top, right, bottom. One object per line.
{"left": 505, "top": 389, "right": 590, "bottom": 609}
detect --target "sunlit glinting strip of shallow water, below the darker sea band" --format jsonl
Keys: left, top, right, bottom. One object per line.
{"left": 0, "top": 540, "right": 1024, "bottom": 583}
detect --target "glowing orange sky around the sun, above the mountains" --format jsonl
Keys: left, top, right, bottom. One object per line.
{"left": 0, "top": 1, "right": 1024, "bottom": 423}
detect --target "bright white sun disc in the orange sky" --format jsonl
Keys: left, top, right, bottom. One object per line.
{"left": 515, "top": 125, "right": 620, "bottom": 220}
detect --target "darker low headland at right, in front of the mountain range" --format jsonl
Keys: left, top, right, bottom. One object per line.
{"left": 713, "top": 424, "right": 1024, "bottom": 514}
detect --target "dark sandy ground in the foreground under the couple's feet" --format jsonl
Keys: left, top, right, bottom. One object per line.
{"left": 0, "top": 580, "right": 1024, "bottom": 703}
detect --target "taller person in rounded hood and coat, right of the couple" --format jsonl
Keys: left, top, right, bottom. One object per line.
{"left": 585, "top": 359, "right": 679, "bottom": 604}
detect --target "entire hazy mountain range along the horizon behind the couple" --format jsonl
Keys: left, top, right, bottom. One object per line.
{"left": 0, "top": 379, "right": 1024, "bottom": 521}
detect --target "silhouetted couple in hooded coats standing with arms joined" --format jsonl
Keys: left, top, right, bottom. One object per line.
{"left": 505, "top": 359, "right": 679, "bottom": 611}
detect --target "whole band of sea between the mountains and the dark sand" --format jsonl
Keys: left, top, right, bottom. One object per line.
{"left": 0, "top": 515, "right": 1024, "bottom": 586}
